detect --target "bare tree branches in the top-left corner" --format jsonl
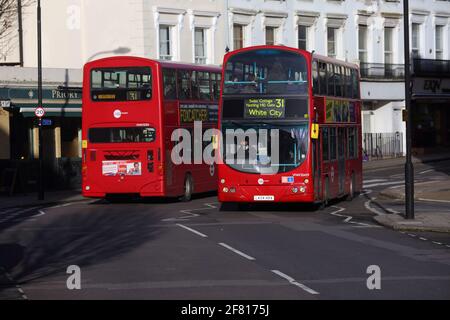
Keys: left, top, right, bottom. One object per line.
{"left": 0, "top": 0, "right": 36, "bottom": 60}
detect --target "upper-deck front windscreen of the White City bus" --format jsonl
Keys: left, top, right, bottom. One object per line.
{"left": 223, "top": 49, "right": 308, "bottom": 95}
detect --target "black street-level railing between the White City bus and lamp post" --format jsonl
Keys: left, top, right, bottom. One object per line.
{"left": 363, "top": 132, "right": 403, "bottom": 161}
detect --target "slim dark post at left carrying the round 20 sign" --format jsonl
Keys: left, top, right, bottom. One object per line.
{"left": 37, "top": 0, "right": 44, "bottom": 200}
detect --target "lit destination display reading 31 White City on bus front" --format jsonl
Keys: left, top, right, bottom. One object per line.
{"left": 244, "top": 98, "right": 286, "bottom": 119}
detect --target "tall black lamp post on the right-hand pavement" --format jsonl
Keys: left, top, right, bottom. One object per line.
{"left": 403, "top": 0, "right": 414, "bottom": 219}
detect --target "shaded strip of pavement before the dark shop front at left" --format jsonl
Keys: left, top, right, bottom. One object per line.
{"left": 0, "top": 190, "right": 87, "bottom": 210}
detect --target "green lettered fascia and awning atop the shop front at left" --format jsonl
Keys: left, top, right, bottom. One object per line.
{"left": 0, "top": 87, "right": 81, "bottom": 117}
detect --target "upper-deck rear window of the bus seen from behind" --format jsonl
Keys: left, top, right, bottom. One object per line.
{"left": 91, "top": 67, "right": 152, "bottom": 102}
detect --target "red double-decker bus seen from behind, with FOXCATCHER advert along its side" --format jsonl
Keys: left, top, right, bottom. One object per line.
{"left": 82, "top": 57, "right": 221, "bottom": 200}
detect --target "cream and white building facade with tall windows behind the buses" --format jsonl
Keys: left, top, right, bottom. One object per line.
{"left": 0, "top": 0, "right": 450, "bottom": 165}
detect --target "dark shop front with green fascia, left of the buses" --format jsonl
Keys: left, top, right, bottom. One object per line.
{"left": 0, "top": 85, "right": 81, "bottom": 191}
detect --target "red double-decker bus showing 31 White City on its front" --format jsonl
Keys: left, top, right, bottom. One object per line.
{"left": 218, "top": 46, "right": 362, "bottom": 203}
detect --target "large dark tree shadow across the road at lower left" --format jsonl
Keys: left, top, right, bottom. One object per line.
{"left": 0, "top": 208, "right": 162, "bottom": 291}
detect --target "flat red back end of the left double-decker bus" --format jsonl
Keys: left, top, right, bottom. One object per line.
{"left": 82, "top": 57, "right": 164, "bottom": 197}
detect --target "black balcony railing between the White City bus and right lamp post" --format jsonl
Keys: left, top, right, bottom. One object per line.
{"left": 360, "top": 62, "right": 405, "bottom": 81}
